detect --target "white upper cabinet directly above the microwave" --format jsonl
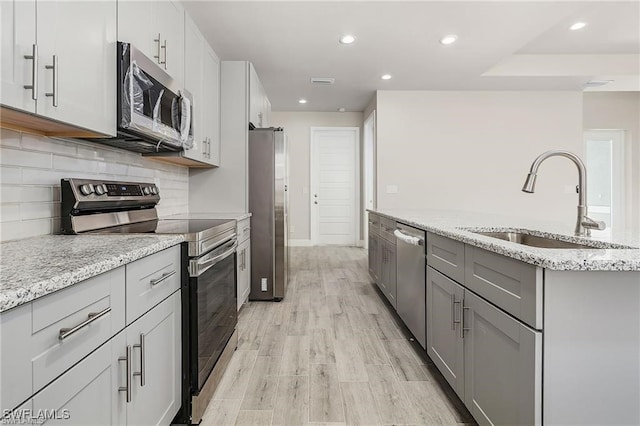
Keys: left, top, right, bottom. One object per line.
{"left": 118, "top": 1, "right": 184, "bottom": 82}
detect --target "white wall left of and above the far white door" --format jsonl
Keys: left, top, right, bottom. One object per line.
{"left": 271, "top": 111, "right": 363, "bottom": 240}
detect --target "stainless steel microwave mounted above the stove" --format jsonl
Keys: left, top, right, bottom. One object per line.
{"left": 94, "top": 42, "right": 193, "bottom": 154}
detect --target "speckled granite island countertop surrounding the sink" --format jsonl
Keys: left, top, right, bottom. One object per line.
{"left": 369, "top": 209, "right": 640, "bottom": 272}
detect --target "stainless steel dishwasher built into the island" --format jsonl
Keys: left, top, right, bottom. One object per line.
{"left": 393, "top": 223, "right": 427, "bottom": 348}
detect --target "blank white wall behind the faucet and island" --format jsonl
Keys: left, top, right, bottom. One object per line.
{"left": 377, "top": 91, "right": 583, "bottom": 231}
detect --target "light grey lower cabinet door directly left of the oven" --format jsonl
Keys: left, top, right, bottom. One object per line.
{"left": 126, "top": 291, "right": 182, "bottom": 425}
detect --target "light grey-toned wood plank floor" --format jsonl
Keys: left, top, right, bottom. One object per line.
{"left": 202, "top": 247, "right": 475, "bottom": 426}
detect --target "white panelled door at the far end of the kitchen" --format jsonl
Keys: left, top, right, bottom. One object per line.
{"left": 310, "top": 127, "right": 360, "bottom": 245}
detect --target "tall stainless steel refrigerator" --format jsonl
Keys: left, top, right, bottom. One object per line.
{"left": 249, "top": 127, "right": 289, "bottom": 301}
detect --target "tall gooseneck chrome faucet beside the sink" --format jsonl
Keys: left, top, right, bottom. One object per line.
{"left": 522, "top": 151, "right": 606, "bottom": 237}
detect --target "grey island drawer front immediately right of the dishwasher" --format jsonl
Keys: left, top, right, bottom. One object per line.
{"left": 427, "top": 233, "right": 464, "bottom": 283}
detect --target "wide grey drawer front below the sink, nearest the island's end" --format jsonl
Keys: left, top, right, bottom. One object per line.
{"left": 464, "top": 245, "right": 542, "bottom": 330}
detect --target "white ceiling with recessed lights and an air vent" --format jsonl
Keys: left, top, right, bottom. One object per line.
{"left": 185, "top": 0, "right": 640, "bottom": 111}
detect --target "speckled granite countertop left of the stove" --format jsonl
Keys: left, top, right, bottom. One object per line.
{"left": 0, "top": 234, "right": 184, "bottom": 312}
